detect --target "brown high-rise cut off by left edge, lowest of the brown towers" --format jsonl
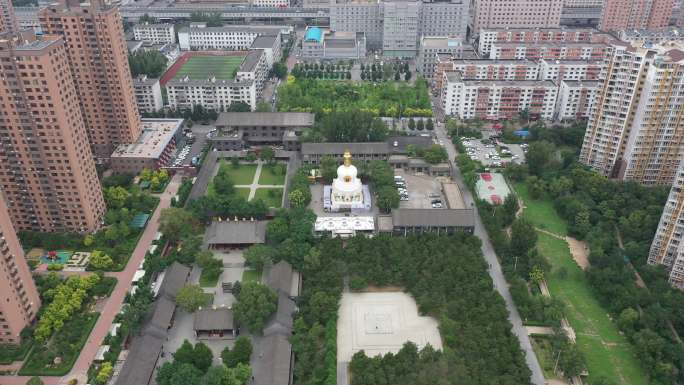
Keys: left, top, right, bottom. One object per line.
{"left": 0, "top": 191, "right": 40, "bottom": 344}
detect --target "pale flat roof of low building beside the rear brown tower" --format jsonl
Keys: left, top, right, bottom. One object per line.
{"left": 112, "top": 119, "right": 183, "bottom": 159}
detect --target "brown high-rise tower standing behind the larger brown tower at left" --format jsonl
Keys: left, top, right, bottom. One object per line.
{"left": 39, "top": 0, "right": 141, "bottom": 159}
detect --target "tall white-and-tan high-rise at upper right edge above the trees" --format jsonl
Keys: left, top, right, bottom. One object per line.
{"left": 580, "top": 42, "right": 684, "bottom": 185}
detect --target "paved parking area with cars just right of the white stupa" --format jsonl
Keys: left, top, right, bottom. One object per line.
{"left": 395, "top": 170, "right": 446, "bottom": 209}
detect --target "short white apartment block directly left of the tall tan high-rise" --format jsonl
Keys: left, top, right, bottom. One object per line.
{"left": 556, "top": 80, "right": 602, "bottom": 120}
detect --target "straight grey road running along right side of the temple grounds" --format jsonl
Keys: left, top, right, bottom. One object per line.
{"left": 435, "top": 123, "right": 546, "bottom": 385}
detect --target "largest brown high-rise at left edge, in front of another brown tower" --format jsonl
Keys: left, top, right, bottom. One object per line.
{"left": 0, "top": 31, "right": 105, "bottom": 232}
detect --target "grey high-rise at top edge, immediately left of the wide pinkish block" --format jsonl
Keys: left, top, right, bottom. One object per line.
{"left": 418, "top": 0, "right": 470, "bottom": 41}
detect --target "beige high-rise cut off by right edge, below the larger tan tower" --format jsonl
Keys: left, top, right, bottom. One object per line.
{"left": 648, "top": 158, "right": 684, "bottom": 290}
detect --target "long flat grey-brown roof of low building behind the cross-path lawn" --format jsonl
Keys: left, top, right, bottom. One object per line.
{"left": 215, "top": 112, "right": 315, "bottom": 127}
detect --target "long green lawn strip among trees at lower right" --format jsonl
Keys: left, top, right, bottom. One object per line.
{"left": 537, "top": 233, "right": 648, "bottom": 385}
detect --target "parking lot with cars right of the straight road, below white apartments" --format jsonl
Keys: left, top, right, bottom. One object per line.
{"left": 461, "top": 135, "right": 527, "bottom": 167}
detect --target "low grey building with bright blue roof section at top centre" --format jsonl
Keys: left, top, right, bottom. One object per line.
{"left": 302, "top": 27, "right": 366, "bottom": 60}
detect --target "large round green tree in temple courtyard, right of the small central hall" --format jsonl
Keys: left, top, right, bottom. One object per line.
{"left": 233, "top": 282, "right": 278, "bottom": 333}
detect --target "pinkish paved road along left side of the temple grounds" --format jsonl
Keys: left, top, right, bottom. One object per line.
{"left": 0, "top": 174, "right": 181, "bottom": 385}
